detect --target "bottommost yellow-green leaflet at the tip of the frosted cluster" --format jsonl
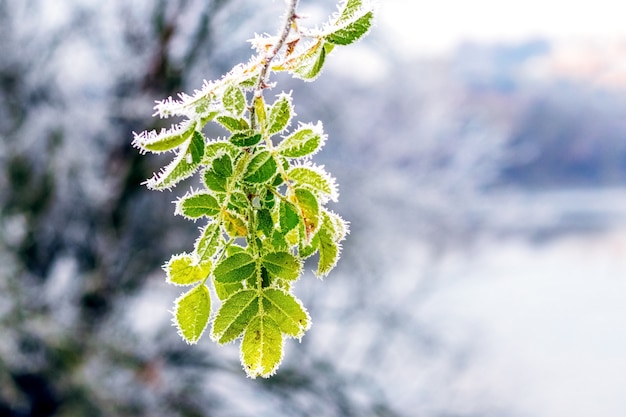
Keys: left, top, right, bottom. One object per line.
{"left": 241, "top": 315, "right": 283, "bottom": 378}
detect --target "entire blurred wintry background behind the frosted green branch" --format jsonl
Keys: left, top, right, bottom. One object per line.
{"left": 0, "top": 0, "right": 626, "bottom": 417}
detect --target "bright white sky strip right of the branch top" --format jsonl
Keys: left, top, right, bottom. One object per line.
{"left": 378, "top": 0, "right": 626, "bottom": 55}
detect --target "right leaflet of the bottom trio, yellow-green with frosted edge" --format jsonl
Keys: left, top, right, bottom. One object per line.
{"left": 263, "top": 288, "right": 311, "bottom": 338}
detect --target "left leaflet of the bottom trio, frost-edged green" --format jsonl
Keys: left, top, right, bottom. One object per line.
{"left": 211, "top": 290, "right": 259, "bottom": 344}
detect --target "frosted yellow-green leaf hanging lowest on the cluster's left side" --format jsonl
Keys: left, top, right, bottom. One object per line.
{"left": 174, "top": 284, "right": 211, "bottom": 344}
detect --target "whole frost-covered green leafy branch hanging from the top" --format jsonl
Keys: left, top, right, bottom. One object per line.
{"left": 133, "top": 0, "right": 373, "bottom": 378}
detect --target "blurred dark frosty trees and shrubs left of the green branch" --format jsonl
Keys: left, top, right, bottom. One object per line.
{"left": 0, "top": 0, "right": 404, "bottom": 417}
